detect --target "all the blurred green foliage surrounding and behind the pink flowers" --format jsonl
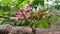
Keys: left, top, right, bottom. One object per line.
{"left": 0, "top": 0, "right": 60, "bottom": 28}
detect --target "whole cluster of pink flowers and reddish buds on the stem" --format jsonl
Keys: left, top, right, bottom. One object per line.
{"left": 11, "top": 5, "right": 48, "bottom": 21}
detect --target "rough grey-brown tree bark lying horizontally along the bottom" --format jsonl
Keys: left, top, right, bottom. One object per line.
{"left": 0, "top": 24, "right": 60, "bottom": 34}
